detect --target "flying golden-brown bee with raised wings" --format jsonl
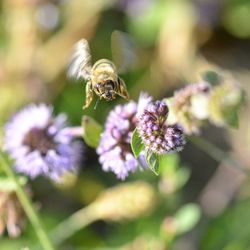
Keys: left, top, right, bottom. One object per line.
{"left": 68, "top": 31, "right": 134, "bottom": 109}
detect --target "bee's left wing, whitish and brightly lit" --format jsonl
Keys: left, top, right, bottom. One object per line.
{"left": 68, "top": 39, "right": 92, "bottom": 80}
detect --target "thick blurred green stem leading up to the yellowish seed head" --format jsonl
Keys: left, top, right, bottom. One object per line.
{"left": 51, "top": 203, "right": 99, "bottom": 245}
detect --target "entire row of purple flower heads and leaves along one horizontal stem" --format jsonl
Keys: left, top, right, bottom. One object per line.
{"left": 3, "top": 69, "right": 242, "bottom": 181}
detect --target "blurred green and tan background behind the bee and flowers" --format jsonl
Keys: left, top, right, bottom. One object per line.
{"left": 0, "top": 0, "right": 250, "bottom": 250}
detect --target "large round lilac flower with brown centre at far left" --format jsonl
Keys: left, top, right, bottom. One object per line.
{"left": 4, "top": 104, "right": 81, "bottom": 180}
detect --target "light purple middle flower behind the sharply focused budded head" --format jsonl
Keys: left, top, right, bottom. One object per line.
{"left": 97, "top": 94, "right": 151, "bottom": 180}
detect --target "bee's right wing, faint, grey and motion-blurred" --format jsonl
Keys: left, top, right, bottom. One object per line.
{"left": 111, "top": 30, "right": 138, "bottom": 73}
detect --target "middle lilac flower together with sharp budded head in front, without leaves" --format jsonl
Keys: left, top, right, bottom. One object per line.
{"left": 97, "top": 93, "right": 185, "bottom": 180}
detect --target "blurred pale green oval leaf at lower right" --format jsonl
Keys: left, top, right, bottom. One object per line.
{"left": 175, "top": 203, "right": 201, "bottom": 234}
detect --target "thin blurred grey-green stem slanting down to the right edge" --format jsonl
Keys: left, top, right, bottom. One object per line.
{"left": 188, "top": 136, "right": 249, "bottom": 175}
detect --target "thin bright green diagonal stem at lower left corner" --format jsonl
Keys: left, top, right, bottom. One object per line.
{"left": 0, "top": 151, "right": 54, "bottom": 250}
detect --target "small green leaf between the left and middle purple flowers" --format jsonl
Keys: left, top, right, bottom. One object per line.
{"left": 82, "top": 115, "right": 102, "bottom": 148}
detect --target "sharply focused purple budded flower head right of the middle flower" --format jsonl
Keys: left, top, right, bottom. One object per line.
{"left": 137, "top": 101, "right": 185, "bottom": 154}
